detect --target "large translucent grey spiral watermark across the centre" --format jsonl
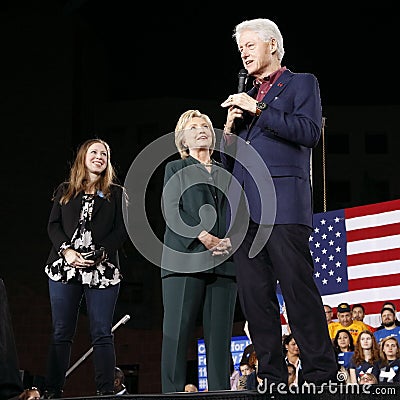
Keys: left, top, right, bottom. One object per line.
{"left": 123, "top": 129, "right": 276, "bottom": 273}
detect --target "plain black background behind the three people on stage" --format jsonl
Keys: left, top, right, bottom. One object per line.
{"left": 0, "top": 0, "right": 400, "bottom": 396}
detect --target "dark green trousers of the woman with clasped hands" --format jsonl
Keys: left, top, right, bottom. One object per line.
{"left": 161, "top": 274, "right": 237, "bottom": 393}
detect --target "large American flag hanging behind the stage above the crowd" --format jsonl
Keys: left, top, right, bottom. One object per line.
{"left": 309, "top": 200, "right": 400, "bottom": 314}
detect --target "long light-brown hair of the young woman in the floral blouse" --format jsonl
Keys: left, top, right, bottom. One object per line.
{"left": 60, "top": 138, "right": 116, "bottom": 204}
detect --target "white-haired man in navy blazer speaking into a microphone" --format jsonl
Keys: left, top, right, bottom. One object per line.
{"left": 221, "top": 19, "right": 337, "bottom": 386}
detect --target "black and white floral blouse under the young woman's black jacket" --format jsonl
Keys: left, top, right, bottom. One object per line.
{"left": 45, "top": 194, "right": 122, "bottom": 289}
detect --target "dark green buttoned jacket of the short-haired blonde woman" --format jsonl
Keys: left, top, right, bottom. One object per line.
{"left": 161, "top": 156, "right": 235, "bottom": 277}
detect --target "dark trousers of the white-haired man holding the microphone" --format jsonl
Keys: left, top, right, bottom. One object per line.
{"left": 234, "top": 221, "right": 337, "bottom": 384}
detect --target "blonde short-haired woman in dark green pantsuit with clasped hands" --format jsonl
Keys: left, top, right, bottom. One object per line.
{"left": 161, "top": 110, "right": 237, "bottom": 393}
